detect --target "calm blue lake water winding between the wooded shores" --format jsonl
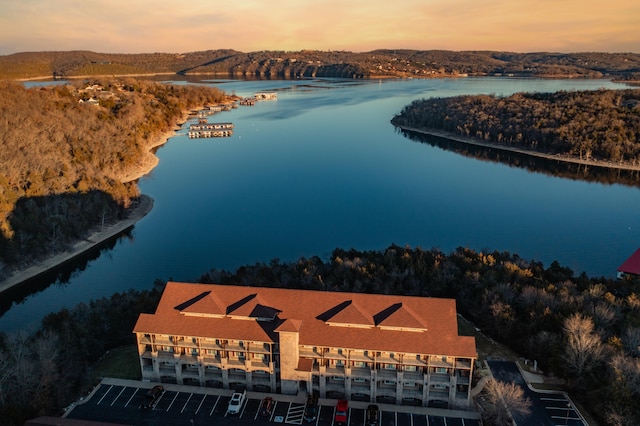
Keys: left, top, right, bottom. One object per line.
{"left": 0, "top": 78, "right": 640, "bottom": 330}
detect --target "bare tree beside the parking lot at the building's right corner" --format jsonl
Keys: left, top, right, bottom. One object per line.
{"left": 483, "top": 379, "right": 531, "bottom": 426}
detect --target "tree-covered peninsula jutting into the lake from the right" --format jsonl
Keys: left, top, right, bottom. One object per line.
{"left": 392, "top": 89, "right": 640, "bottom": 167}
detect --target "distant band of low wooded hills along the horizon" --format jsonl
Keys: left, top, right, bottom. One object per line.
{"left": 0, "top": 49, "right": 640, "bottom": 81}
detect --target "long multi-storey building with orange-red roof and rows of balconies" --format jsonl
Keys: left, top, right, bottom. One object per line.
{"left": 133, "top": 282, "right": 477, "bottom": 408}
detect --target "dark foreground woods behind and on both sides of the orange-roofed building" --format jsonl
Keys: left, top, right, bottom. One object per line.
{"left": 0, "top": 245, "right": 640, "bottom": 425}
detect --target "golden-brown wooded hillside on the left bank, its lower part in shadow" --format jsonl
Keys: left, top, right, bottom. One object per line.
{"left": 0, "top": 80, "right": 225, "bottom": 272}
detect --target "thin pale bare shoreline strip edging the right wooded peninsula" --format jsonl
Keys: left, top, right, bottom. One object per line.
{"left": 394, "top": 124, "right": 640, "bottom": 171}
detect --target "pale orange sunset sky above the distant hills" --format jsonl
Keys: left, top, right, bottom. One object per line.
{"left": 0, "top": 0, "right": 640, "bottom": 55}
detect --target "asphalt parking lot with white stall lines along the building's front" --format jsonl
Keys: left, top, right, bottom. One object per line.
{"left": 66, "top": 381, "right": 480, "bottom": 426}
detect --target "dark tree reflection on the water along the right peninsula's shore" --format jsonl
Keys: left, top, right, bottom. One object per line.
{"left": 398, "top": 129, "right": 640, "bottom": 187}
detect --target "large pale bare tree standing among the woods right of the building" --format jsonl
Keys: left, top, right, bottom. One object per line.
{"left": 563, "top": 314, "right": 605, "bottom": 380}
